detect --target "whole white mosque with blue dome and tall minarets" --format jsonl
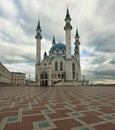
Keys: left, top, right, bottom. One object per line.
{"left": 35, "top": 8, "right": 81, "bottom": 86}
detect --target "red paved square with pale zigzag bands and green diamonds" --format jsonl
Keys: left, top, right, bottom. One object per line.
{"left": 0, "top": 87, "right": 115, "bottom": 130}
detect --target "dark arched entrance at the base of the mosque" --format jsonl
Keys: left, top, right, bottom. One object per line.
{"left": 40, "top": 71, "right": 48, "bottom": 86}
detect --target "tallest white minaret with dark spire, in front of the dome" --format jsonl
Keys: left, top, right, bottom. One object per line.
{"left": 64, "top": 8, "right": 72, "bottom": 59}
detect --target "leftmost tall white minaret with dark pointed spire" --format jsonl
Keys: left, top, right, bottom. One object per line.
{"left": 35, "top": 20, "right": 42, "bottom": 65}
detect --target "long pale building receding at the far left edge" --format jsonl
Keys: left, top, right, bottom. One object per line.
{"left": 0, "top": 62, "right": 11, "bottom": 86}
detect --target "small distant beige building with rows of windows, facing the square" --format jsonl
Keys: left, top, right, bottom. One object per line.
{"left": 11, "top": 72, "right": 26, "bottom": 86}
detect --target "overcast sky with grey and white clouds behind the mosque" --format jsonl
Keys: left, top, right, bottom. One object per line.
{"left": 0, "top": 0, "right": 115, "bottom": 83}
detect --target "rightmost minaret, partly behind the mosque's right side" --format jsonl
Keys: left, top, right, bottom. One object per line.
{"left": 74, "top": 29, "right": 80, "bottom": 64}
